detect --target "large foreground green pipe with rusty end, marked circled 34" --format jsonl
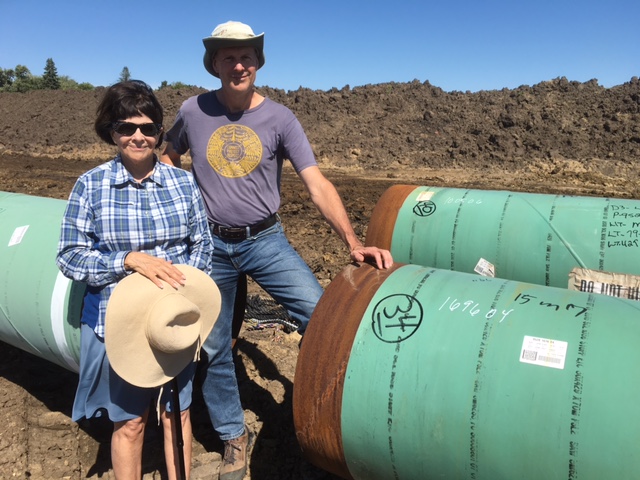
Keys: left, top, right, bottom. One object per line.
{"left": 294, "top": 264, "right": 640, "bottom": 480}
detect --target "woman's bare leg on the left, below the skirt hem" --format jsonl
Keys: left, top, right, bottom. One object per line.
{"left": 111, "top": 410, "right": 149, "bottom": 480}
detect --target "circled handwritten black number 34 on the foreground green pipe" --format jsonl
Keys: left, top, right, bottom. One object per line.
{"left": 371, "top": 294, "right": 423, "bottom": 343}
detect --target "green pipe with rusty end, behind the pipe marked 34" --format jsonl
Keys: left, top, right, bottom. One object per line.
{"left": 366, "top": 185, "right": 640, "bottom": 288}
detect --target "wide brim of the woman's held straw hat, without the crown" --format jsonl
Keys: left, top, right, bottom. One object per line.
{"left": 105, "top": 265, "right": 221, "bottom": 388}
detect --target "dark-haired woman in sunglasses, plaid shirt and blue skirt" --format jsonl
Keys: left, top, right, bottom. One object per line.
{"left": 56, "top": 80, "right": 212, "bottom": 479}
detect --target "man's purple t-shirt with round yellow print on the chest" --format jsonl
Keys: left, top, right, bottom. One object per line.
{"left": 167, "top": 92, "right": 317, "bottom": 227}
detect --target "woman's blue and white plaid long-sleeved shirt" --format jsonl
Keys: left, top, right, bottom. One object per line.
{"left": 56, "top": 156, "right": 213, "bottom": 337}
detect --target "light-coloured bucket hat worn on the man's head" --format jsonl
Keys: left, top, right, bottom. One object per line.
{"left": 202, "top": 21, "right": 264, "bottom": 78}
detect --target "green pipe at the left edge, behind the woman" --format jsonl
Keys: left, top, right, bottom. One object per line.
{"left": 0, "top": 192, "right": 85, "bottom": 372}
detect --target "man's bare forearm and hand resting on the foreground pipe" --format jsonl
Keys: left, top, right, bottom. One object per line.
{"left": 300, "top": 166, "right": 393, "bottom": 268}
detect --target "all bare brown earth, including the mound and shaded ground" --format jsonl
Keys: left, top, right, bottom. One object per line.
{"left": 0, "top": 77, "right": 640, "bottom": 480}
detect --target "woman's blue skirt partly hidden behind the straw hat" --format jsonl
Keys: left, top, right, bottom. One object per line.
{"left": 71, "top": 323, "right": 196, "bottom": 422}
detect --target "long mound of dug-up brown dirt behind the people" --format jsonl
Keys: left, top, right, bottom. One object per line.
{"left": 0, "top": 77, "right": 640, "bottom": 173}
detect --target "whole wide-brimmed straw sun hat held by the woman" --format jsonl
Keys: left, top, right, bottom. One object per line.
{"left": 105, "top": 265, "right": 220, "bottom": 387}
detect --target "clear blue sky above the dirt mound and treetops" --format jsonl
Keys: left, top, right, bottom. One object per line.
{"left": 0, "top": 0, "right": 640, "bottom": 92}
